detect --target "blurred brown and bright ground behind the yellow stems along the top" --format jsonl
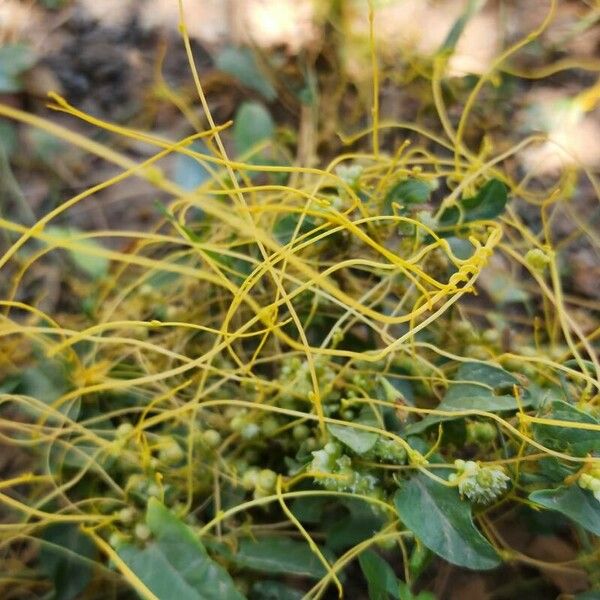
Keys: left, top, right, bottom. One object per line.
{"left": 0, "top": 0, "right": 600, "bottom": 303}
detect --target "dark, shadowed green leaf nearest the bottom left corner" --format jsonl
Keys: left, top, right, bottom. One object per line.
{"left": 39, "top": 523, "right": 96, "bottom": 600}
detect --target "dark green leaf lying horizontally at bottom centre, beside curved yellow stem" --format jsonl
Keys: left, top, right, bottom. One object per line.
{"left": 232, "top": 537, "right": 325, "bottom": 579}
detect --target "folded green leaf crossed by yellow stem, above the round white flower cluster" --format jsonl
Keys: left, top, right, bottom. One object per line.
{"left": 406, "top": 362, "right": 532, "bottom": 435}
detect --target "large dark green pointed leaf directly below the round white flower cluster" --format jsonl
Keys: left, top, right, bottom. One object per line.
{"left": 394, "top": 473, "right": 500, "bottom": 570}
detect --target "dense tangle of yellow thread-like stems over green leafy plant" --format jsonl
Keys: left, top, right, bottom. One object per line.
{"left": 0, "top": 1, "right": 600, "bottom": 600}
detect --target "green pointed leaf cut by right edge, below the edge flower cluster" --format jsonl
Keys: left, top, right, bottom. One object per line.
{"left": 529, "top": 485, "right": 600, "bottom": 535}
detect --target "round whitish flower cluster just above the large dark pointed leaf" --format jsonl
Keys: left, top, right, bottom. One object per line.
{"left": 448, "top": 459, "right": 510, "bottom": 504}
